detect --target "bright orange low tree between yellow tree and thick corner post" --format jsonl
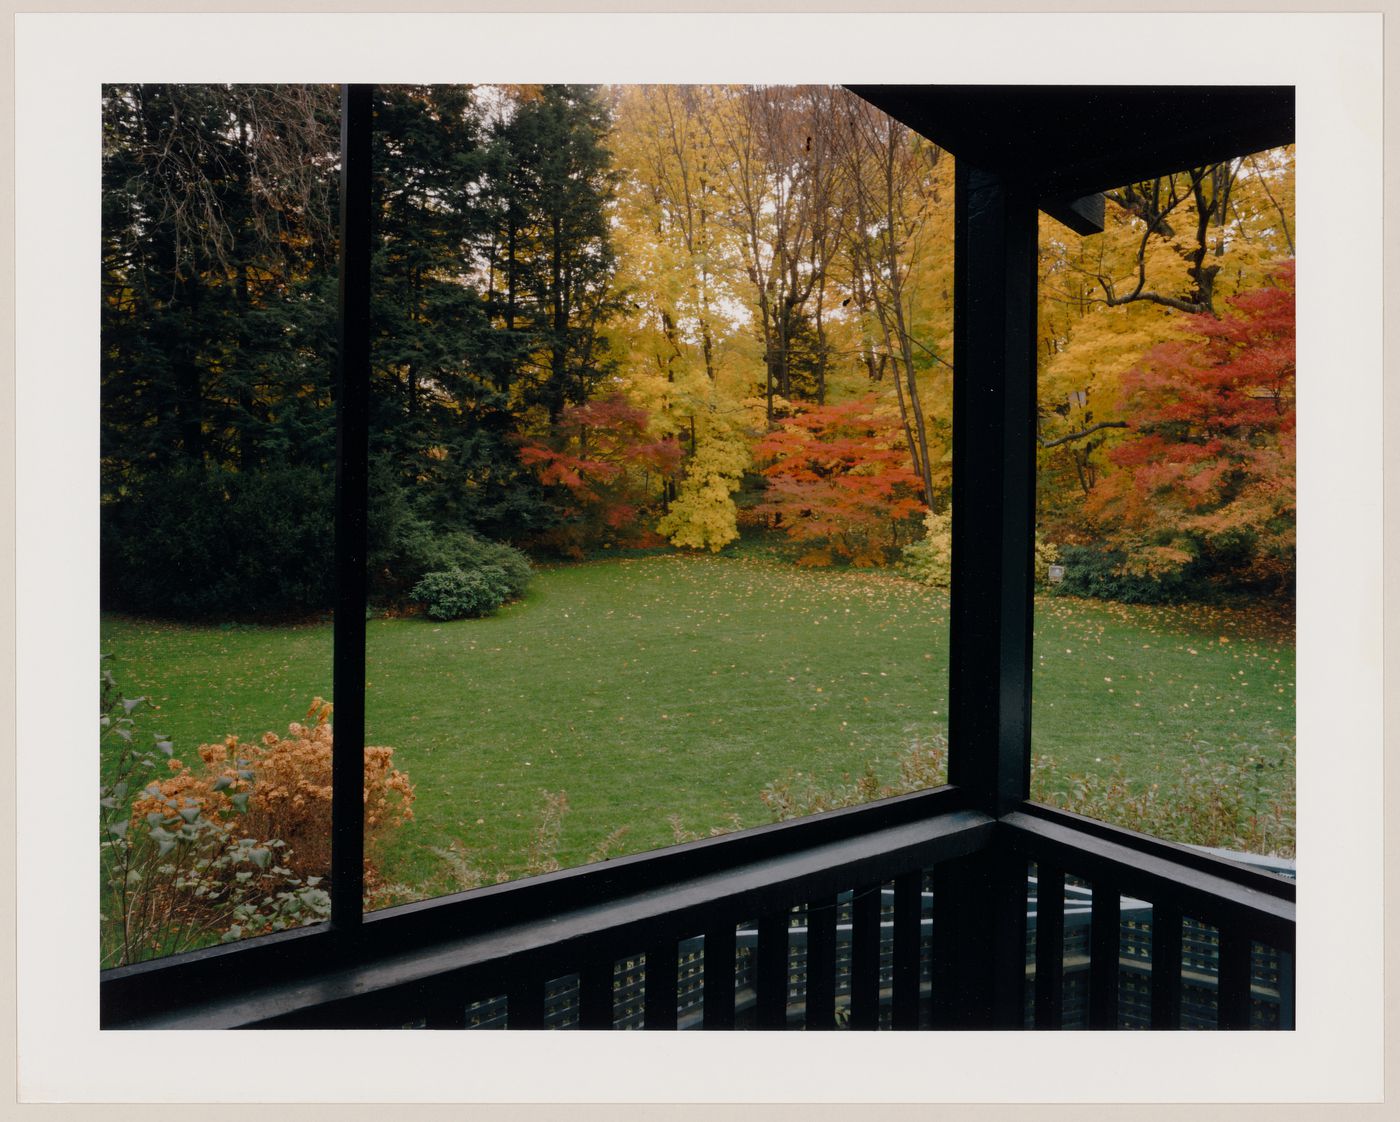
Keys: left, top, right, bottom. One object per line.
{"left": 753, "top": 395, "right": 925, "bottom": 566}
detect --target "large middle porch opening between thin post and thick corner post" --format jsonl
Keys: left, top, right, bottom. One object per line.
{"left": 355, "top": 85, "right": 952, "bottom": 908}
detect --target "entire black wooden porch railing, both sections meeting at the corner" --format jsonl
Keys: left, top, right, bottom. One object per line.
{"left": 102, "top": 789, "right": 1294, "bottom": 1030}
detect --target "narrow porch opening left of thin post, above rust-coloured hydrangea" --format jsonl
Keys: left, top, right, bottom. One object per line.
{"left": 101, "top": 84, "right": 339, "bottom": 967}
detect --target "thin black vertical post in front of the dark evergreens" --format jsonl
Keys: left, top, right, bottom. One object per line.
{"left": 330, "top": 85, "right": 374, "bottom": 931}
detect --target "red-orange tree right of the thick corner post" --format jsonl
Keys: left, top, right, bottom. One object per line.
{"left": 1088, "top": 261, "right": 1296, "bottom": 587}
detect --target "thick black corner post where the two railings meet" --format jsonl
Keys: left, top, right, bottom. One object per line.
{"left": 935, "top": 161, "right": 1039, "bottom": 1028}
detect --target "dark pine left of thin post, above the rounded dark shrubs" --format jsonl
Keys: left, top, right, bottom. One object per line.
{"left": 102, "top": 85, "right": 335, "bottom": 489}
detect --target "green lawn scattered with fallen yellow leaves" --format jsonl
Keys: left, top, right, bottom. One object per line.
{"left": 102, "top": 555, "right": 1294, "bottom": 885}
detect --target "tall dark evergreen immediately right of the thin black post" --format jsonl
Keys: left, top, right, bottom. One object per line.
{"left": 372, "top": 85, "right": 554, "bottom": 538}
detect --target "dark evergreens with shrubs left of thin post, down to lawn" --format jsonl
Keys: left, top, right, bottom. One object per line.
{"left": 101, "top": 85, "right": 336, "bottom": 615}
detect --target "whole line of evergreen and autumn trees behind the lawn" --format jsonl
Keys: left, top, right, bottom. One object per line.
{"left": 102, "top": 85, "right": 1294, "bottom": 615}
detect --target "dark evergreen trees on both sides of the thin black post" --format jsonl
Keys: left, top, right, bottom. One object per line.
{"left": 102, "top": 85, "right": 619, "bottom": 615}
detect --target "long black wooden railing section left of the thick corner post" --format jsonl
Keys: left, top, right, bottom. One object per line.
{"left": 102, "top": 789, "right": 995, "bottom": 1028}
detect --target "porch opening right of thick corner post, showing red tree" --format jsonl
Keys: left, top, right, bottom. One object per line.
{"left": 1032, "top": 148, "right": 1295, "bottom": 857}
